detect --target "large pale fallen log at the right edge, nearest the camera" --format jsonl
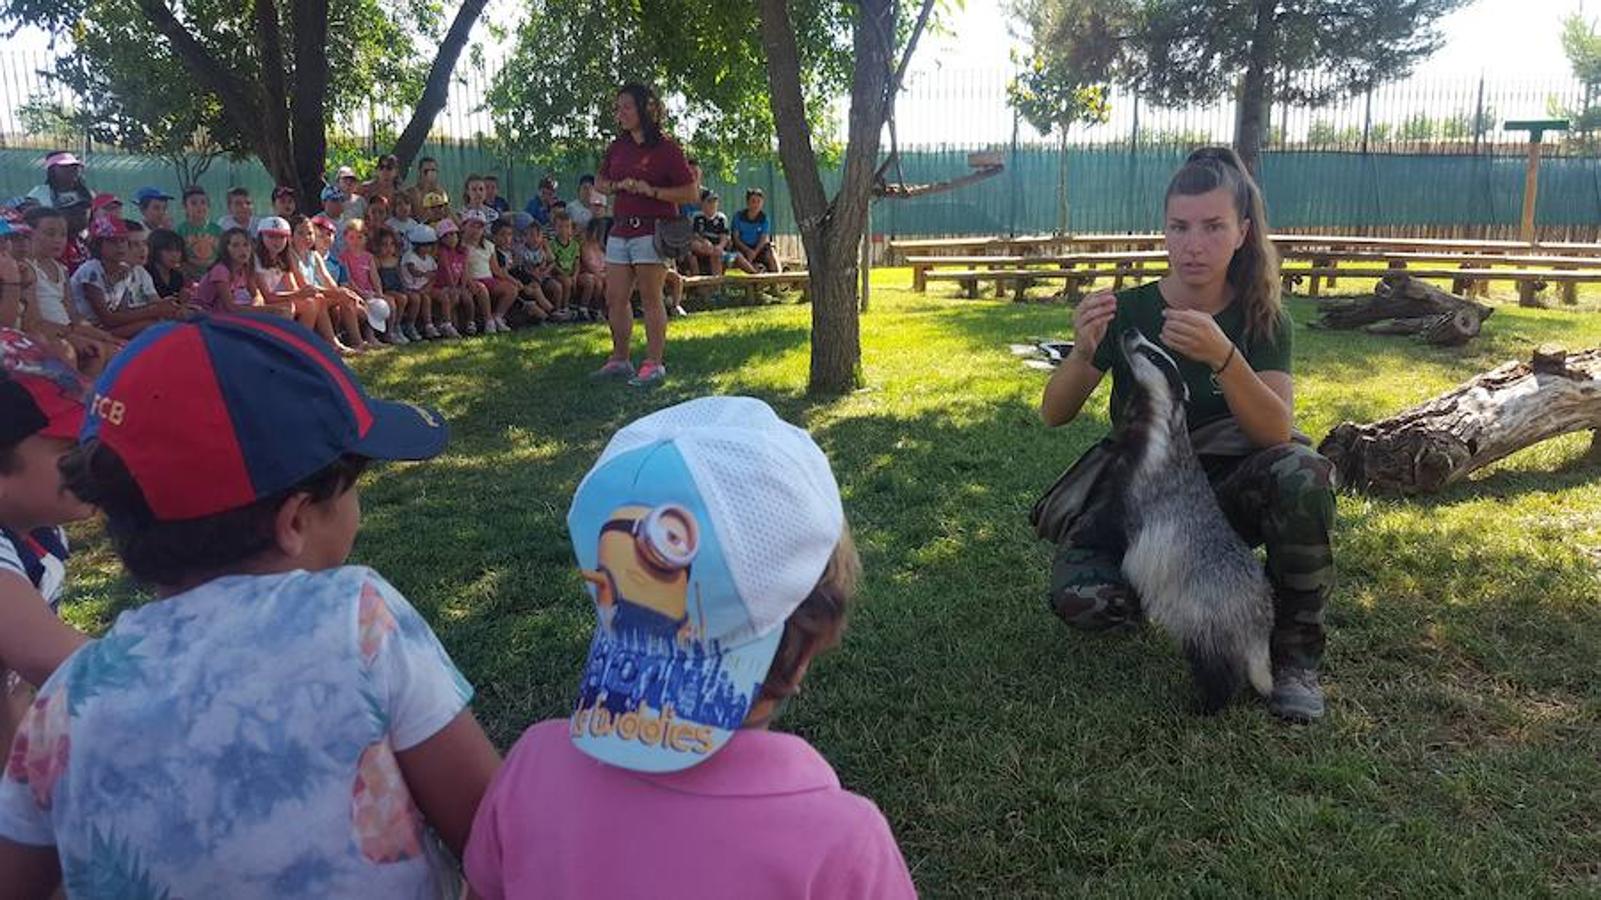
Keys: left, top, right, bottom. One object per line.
{"left": 1318, "top": 344, "right": 1601, "bottom": 493}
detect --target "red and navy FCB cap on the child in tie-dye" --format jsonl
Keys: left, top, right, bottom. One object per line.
{"left": 80, "top": 315, "right": 450, "bottom": 522}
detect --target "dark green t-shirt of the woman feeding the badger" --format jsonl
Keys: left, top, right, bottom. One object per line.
{"left": 1095, "top": 282, "right": 1294, "bottom": 429}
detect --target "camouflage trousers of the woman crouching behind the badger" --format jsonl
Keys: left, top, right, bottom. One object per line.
{"left": 1050, "top": 444, "right": 1334, "bottom": 668}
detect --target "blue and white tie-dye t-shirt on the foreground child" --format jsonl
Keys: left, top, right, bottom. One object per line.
{"left": 0, "top": 567, "right": 472, "bottom": 898}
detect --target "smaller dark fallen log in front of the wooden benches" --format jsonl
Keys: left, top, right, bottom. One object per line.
{"left": 1313, "top": 275, "right": 1495, "bottom": 346}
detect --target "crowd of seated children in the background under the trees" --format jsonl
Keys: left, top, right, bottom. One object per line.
{"left": 0, "top": 152, "right": 736, "bottom": 375}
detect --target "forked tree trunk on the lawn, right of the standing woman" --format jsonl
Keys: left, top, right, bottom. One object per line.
{"left": 759, "top": 0, "right": 902, "bottom": 394}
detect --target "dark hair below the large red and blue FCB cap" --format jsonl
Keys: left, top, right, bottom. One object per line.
{"left": 61, "top": 439, "right": 367, "bottom": 586}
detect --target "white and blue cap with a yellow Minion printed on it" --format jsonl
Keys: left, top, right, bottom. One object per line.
{"left": 567, "top": 397, "right": 845, "bottom": 772}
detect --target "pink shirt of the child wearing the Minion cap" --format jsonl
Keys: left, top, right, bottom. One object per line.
{"left": 464, "top": 719, "right": 917, "bottom": 900}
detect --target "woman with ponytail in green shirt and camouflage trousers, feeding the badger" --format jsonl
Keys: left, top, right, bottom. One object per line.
{"left": 1041, "top": 147, "right": 1335, "bottom": 721}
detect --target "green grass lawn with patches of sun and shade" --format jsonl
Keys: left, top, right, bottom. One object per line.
{"left": 67, "top": 269, "right": 1601, "bottom": 897}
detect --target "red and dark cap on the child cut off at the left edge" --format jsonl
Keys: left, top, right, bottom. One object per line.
{"left": 0, "top": 328, "right": 88, "bottom": 445}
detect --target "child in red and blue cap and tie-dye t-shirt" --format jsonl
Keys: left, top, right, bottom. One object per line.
{"left": 0, "top": 315, "right": 498, "bottom": 898}
